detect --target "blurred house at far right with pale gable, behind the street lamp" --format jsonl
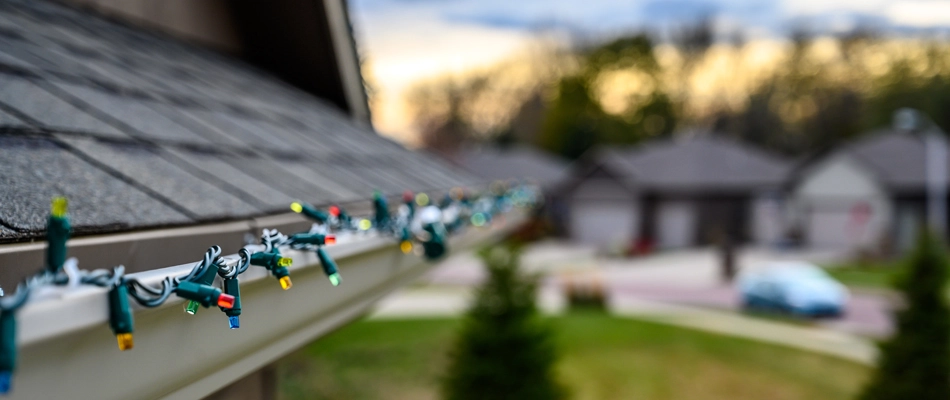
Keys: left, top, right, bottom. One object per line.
{"left": 789, "top": 130, "right": 946, "bottom": 252}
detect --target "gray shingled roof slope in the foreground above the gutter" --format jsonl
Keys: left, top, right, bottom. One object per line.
{"left": 0, "top": 0, "right": 480, "bottom": 241}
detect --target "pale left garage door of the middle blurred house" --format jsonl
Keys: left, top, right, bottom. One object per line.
{"left": 571, "top": 199, "right": 639, "bottom": 247}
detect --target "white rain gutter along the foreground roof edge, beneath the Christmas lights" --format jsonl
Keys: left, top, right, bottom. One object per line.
{"left": 3, "top": 211, "right": 521, "bottom": 399}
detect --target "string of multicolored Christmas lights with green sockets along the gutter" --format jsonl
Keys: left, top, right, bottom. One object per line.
{"left": 0, "top": 184, "right": 540, "bottom": 394}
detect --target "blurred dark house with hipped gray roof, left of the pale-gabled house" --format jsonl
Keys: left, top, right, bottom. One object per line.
{"left": 569, "top": 134, "right": 789, "bottom": 248}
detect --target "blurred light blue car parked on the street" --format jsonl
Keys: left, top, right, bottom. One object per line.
{"left": 739, "top": 262, "right": 850, "bottom": 317}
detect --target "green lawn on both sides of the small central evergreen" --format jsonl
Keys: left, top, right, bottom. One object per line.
{"left": 278, "top": 312, "right": 868, "bottom": 400}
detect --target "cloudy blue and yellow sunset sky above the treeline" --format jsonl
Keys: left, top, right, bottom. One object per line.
{"left": 348, "top": 0, "right": 950, "bottom": 144}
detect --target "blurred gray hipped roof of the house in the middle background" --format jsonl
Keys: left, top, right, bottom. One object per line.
{"left": 602, "top": 134, "right": 790, "bottom": 192}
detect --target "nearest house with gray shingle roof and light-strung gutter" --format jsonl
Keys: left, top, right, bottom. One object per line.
{"left": 0, "top": 0, "right": 501, "bottom": 399}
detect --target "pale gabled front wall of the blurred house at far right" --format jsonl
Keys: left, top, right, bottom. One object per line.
{"left": 794, "top": 155, "right": 893, "bottom": 250}
